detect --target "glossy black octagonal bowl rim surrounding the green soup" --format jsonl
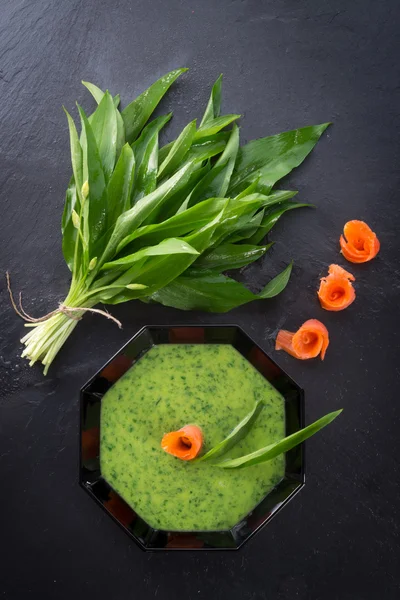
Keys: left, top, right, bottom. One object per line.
{"left": 79, "top": 325, "right": 304, "bottom": 550}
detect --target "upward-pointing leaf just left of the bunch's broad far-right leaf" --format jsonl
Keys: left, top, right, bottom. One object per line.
{"left": 189, "top": 125, "right": 239, "bottom": 206}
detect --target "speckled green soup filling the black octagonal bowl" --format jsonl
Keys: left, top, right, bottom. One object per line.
{"left": 100, "top": 344, "right": 285, "bottom": 531}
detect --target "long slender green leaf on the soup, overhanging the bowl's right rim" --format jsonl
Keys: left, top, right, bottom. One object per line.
{"left": 215, "top": 409, "right": 343, "bottom": 469}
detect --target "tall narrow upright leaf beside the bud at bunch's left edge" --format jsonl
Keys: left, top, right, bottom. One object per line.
{"left": 78, "top": 106, "right": 107, "bottom": 249}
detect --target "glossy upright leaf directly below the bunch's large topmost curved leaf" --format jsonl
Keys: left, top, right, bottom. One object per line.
{"left": 132, "top": 113, "right": 172, "bottom": 204}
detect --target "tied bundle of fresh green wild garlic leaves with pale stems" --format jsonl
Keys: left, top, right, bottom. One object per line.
{"left": 17, "top": 69, "right": 329, "bottom": 373}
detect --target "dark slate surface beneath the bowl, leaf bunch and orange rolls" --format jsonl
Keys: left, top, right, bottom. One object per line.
{"left": 0, "top": 0, "right": 400, "bottom": 600}
